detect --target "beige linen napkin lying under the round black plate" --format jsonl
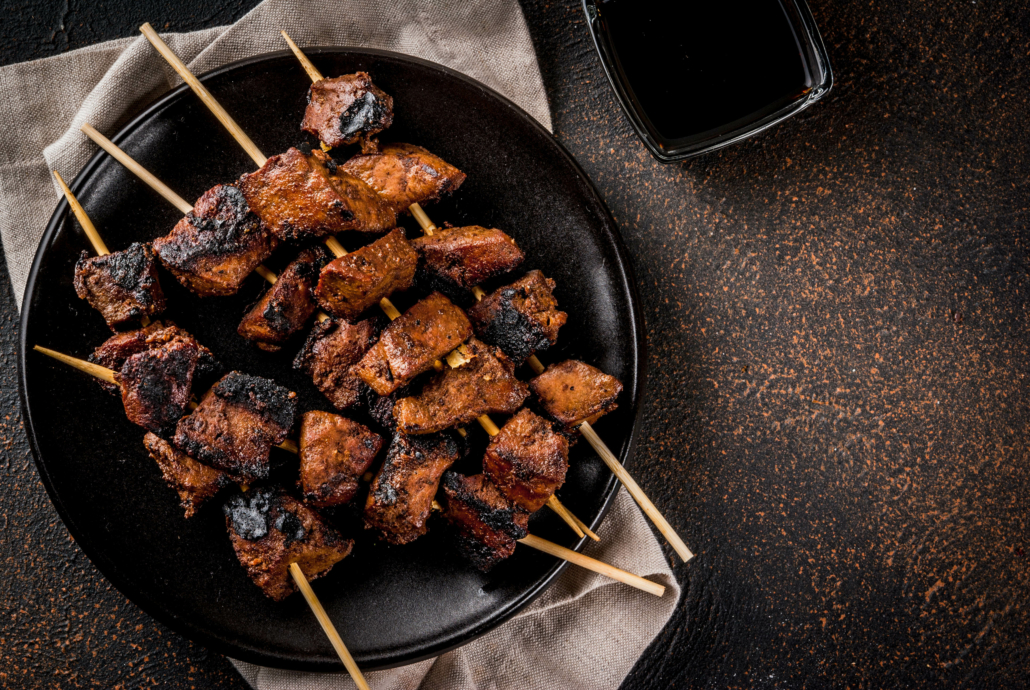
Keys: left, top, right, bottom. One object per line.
{"left": 0, "top": 0, "right": 680, "bottom": 690}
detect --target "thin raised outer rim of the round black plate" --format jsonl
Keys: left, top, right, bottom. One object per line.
{"left": 18, "top": 46, "right": 647, "bottom": 672}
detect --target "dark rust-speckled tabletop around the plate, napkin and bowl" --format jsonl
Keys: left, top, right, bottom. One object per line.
{"left": 0, "top": 0, "right": 1030, "bottom": 690}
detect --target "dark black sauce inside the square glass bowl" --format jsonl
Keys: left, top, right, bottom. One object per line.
{"left": 596, "top": 0, "right": 815, "bottom": 148}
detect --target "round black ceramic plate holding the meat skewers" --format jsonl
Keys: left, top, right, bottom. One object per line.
{"left": 20, "top": 48, "right": 644, "bottom": 670}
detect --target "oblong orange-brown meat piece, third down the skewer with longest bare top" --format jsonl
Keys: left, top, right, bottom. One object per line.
{"left": 352, "top": 292, "right": 472, "bottom": 395}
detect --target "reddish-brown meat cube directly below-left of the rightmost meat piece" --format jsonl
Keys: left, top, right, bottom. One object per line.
{"left": 483, "top": 410, "right": 569, "bottom": 513}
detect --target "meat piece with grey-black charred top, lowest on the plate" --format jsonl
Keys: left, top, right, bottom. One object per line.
{"left": 221, "top": 489, "right": 354, "bottom": 601}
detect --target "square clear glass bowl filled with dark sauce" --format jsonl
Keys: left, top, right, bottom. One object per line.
{"left": 583, "top": 0, "right": 833, "bottom": 163}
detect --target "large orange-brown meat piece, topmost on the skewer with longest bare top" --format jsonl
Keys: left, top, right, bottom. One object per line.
{"left": 239, "top": 148, "right": 397, "bottom": 240}
